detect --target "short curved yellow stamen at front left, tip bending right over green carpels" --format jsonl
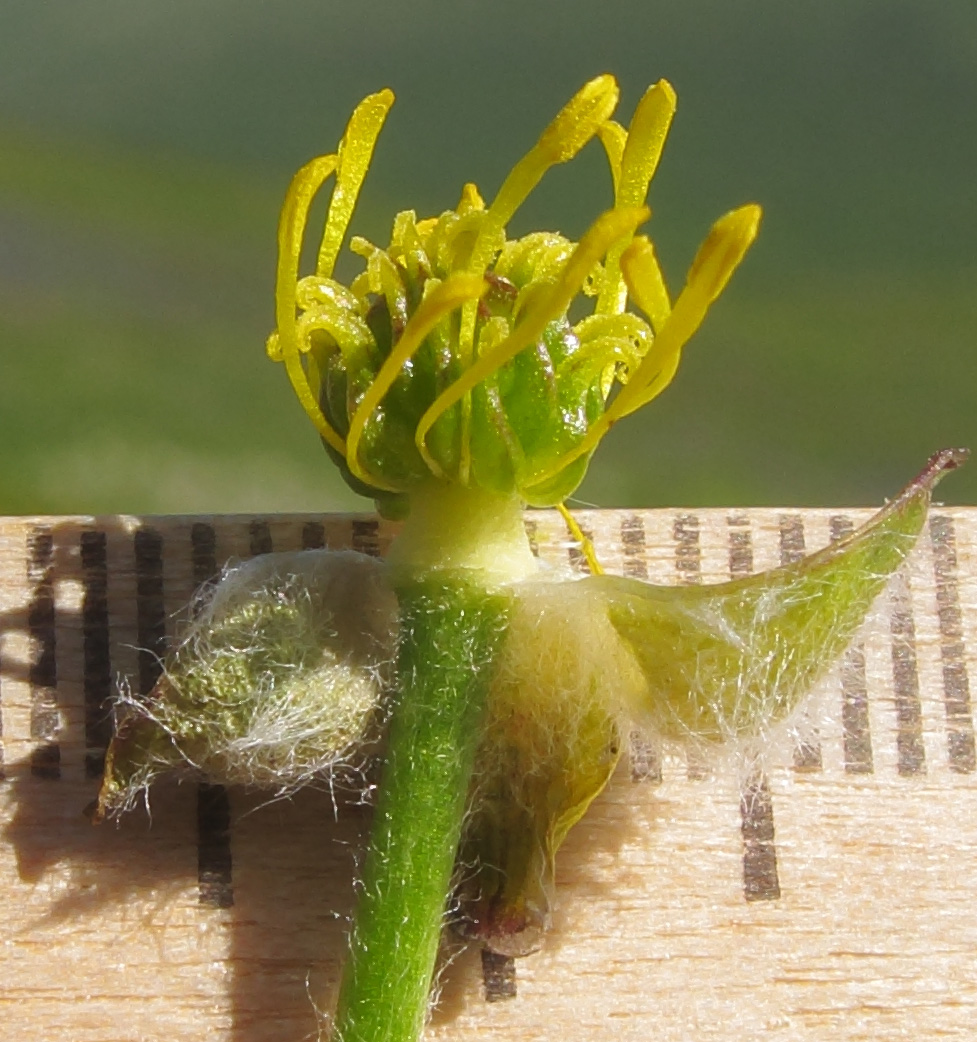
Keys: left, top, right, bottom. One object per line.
{"left": 346, "top": 274, "right": 489, "bottom": 492}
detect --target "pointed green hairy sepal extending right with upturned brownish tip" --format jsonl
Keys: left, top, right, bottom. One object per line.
{"left": 582, "top": 449, "right": 967, "bottom": 740}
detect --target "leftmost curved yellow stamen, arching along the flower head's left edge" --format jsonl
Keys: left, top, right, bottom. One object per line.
{"left": 268, "top": 155, "right": 346, "bottom": 453}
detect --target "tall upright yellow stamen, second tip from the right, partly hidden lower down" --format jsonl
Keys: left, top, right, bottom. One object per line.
{"left": 597, "top": 79, "right": 676, "bottom": 315}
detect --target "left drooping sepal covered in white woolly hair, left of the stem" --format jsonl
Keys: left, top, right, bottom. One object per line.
{"left": 103, "top": 550, "right": 398, "bottom": 811}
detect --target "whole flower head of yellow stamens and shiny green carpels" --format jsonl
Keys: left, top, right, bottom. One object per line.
{"left": 268, "top": 75, "right": 760, "bottom": 513}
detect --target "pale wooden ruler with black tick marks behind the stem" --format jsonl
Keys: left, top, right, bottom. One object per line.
{"left": 0, "top": 508, "right": 977, "bottom": 1042}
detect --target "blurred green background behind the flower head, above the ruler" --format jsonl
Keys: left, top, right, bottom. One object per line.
{"left": 0, "top": 0, "right": 977, "bottom": 513}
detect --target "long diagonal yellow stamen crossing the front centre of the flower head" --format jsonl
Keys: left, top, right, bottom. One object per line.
{"left": 415, "top": 207, "right": 648, "bottom": 477}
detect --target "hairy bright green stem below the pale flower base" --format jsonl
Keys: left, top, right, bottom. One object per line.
{"left": 332, "top": 573, "right": 508, "bottom": 1042}
